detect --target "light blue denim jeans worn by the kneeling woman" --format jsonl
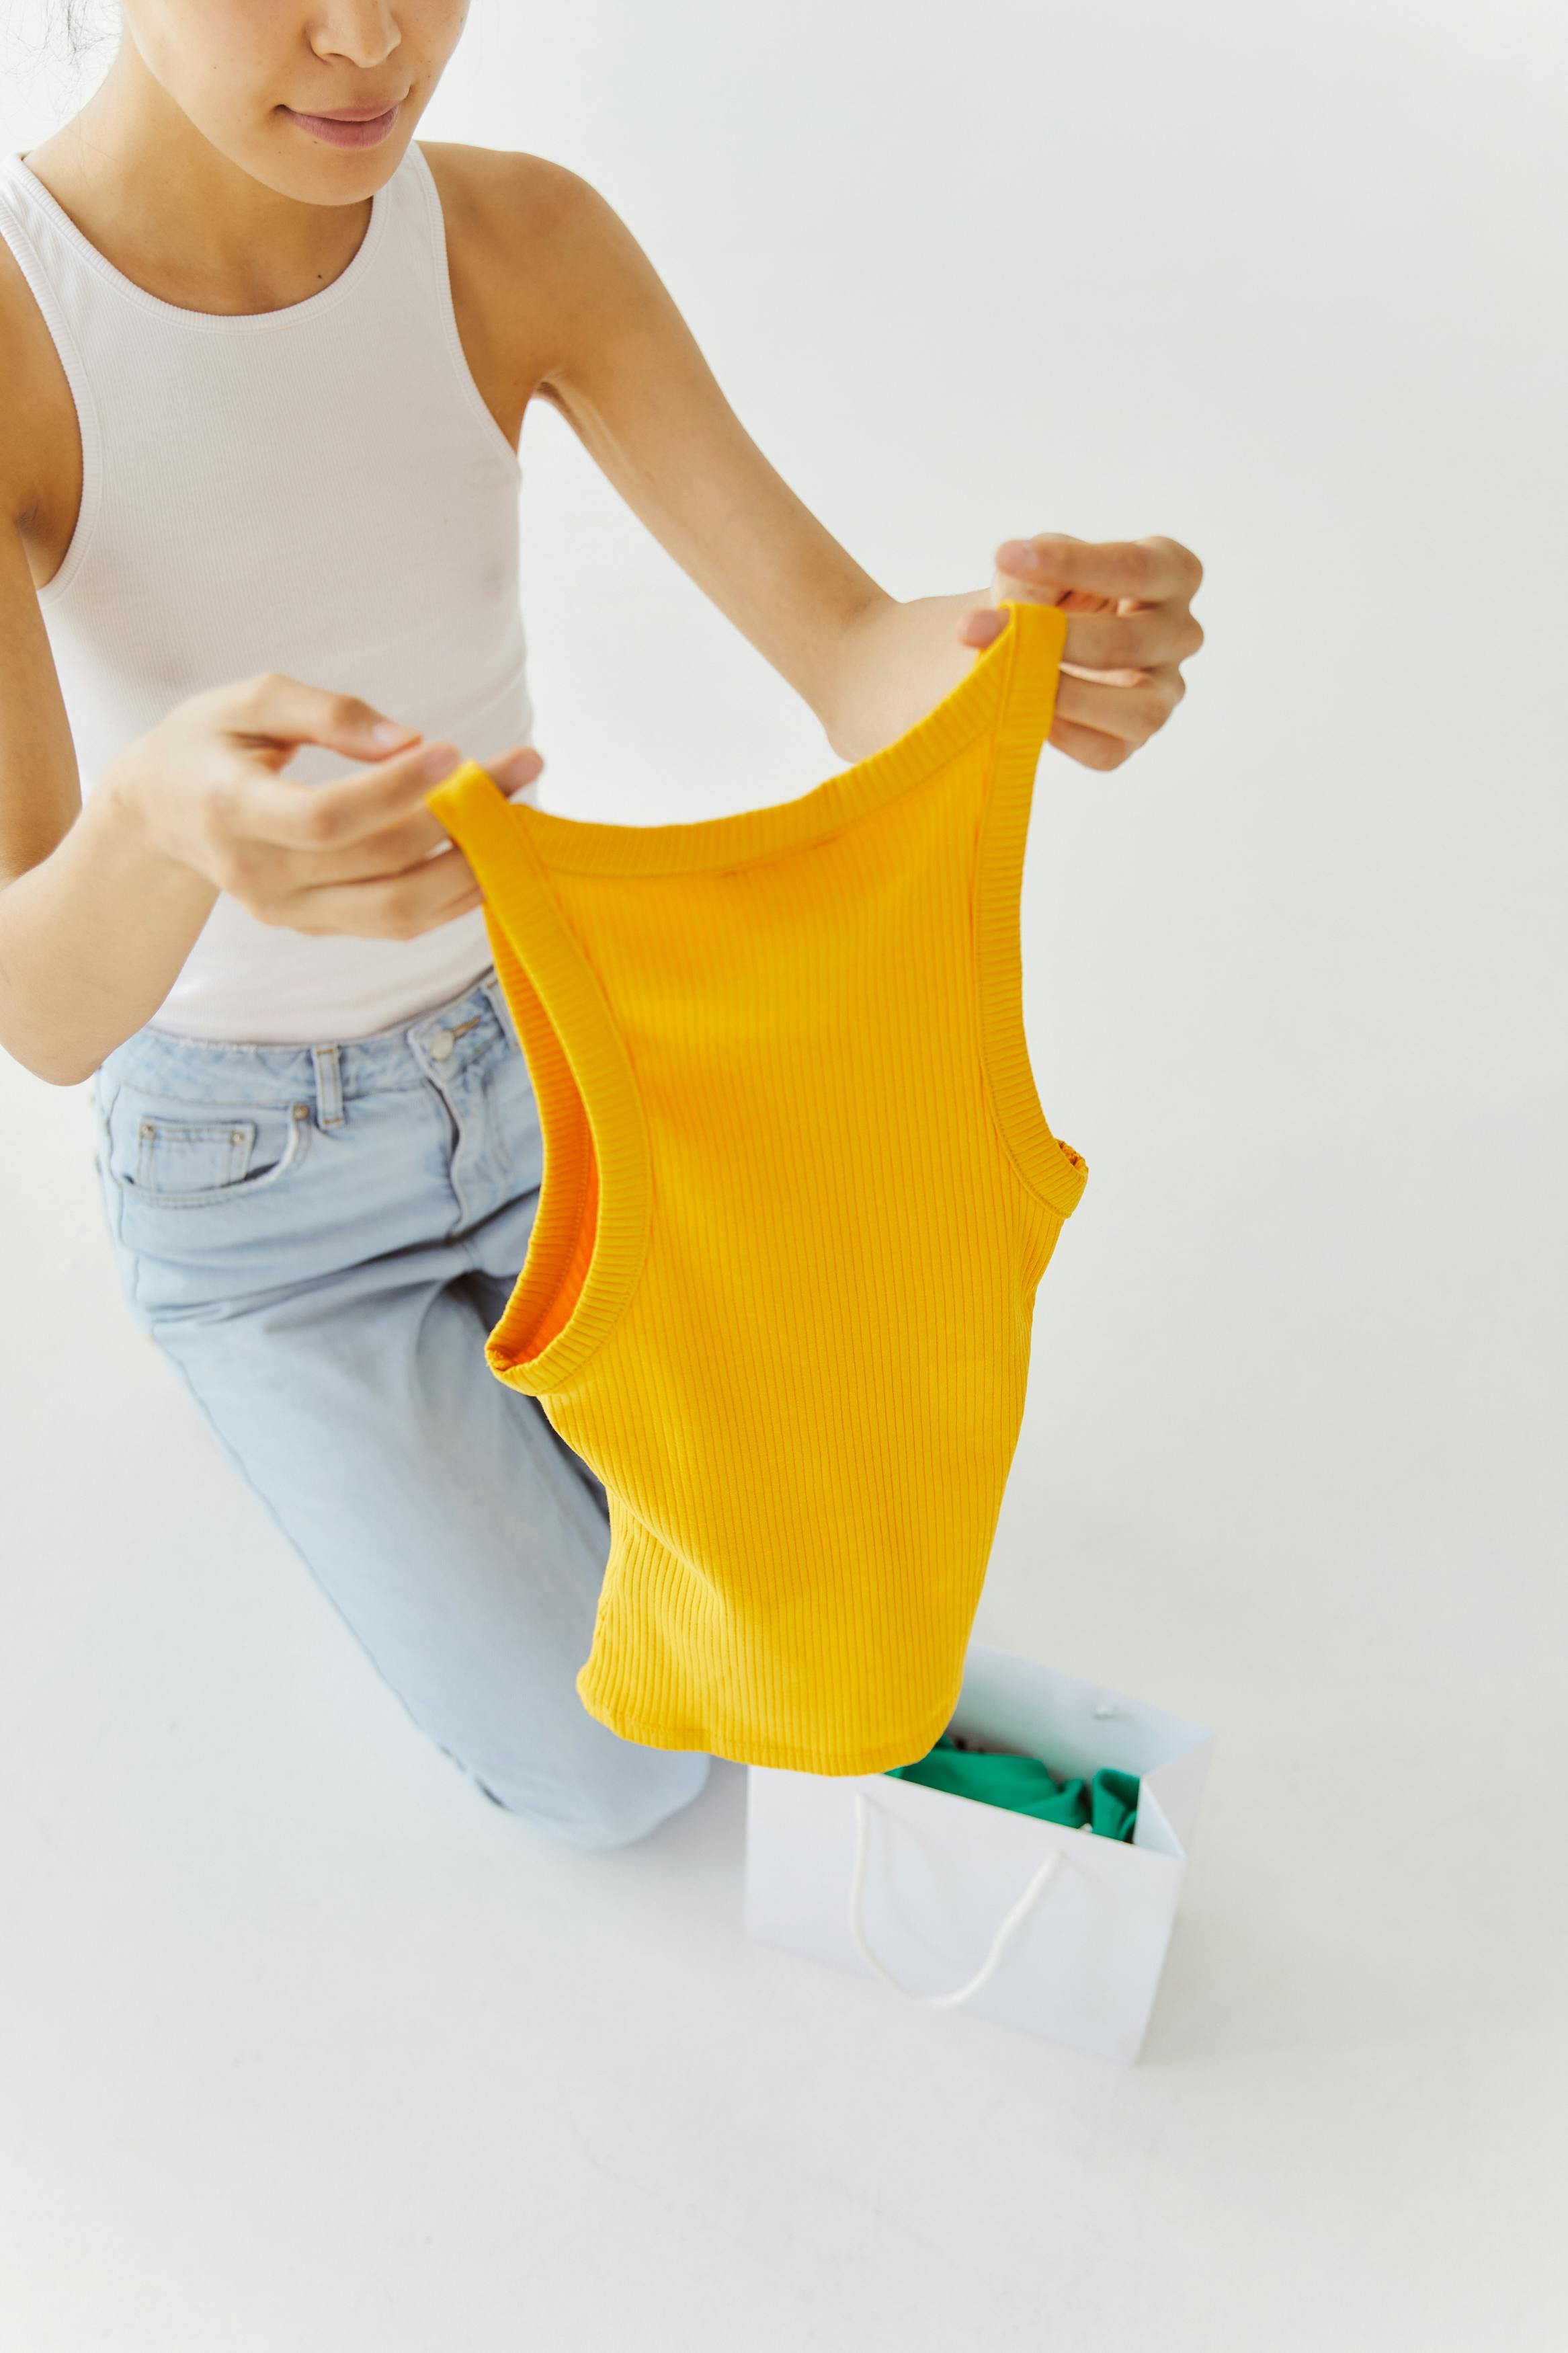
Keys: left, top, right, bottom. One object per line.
{"left": 94, "top": 967, "right": 710, "bottom": 1847}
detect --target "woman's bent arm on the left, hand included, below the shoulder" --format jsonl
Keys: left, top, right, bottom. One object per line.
{"left": 0, "top": 510, "right": 543, "bottom": 1087}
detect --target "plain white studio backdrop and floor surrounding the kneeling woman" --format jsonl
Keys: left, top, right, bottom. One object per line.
{"left": 0, "top": 0, "right": 1568, "bottom": 2353}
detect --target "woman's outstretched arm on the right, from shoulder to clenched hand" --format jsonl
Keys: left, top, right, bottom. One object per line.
{"left": 451, "top": 149, "right": 1204, "bottom": 767}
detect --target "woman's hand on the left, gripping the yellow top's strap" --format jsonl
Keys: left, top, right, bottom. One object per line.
{"left": 104, "top": 671, "right": 543, "bottom": 939}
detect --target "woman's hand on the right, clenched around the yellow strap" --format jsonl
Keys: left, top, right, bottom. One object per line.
{"left": 959, "top": 532, "right": 1204, "bottom": 767}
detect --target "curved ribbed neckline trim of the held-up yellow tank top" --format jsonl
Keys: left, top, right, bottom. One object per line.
{"left": 425, "top": 600, "right": 1067, "bottom": 875}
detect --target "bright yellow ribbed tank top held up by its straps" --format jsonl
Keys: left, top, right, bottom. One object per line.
{"left": 428, "top": 605, "right": 1086, "bottom": 1774}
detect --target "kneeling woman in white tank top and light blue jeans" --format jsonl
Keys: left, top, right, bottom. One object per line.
{"left": 0, "top": 0, "right": 1201, "bottom": 1845}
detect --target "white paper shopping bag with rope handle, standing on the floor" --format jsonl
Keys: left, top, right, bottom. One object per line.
{"left": 745, "top": 1642, "right": 1213, "bottom": 2061}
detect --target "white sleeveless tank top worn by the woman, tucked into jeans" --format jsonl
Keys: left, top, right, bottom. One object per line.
{"left": 0, "top": 141, "right": 536, "bottom": 1045}
